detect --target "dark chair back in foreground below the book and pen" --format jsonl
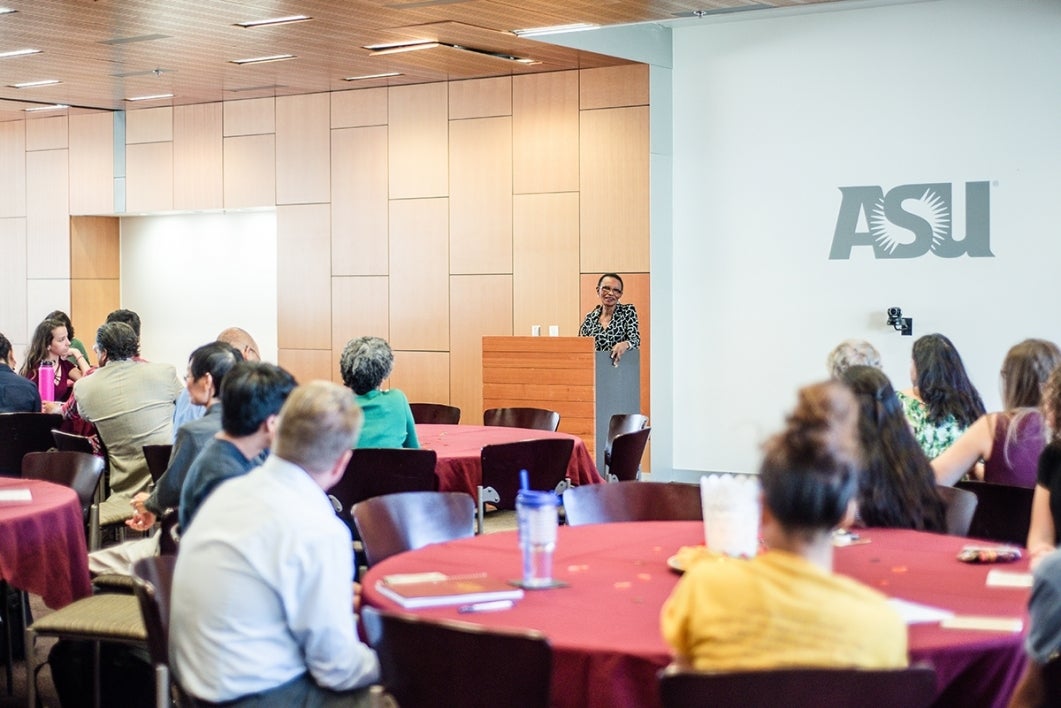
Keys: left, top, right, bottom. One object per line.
{"left": 361, "top": 607, "right": 553, "bottom": 708}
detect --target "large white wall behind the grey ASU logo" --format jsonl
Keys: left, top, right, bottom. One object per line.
{"left": 670, "top": 0, "right": 1061, "bottom": 471}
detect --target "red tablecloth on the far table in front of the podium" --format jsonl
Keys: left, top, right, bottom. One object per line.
{"left": 416, "top": 424, "right": 604, "bottom": 497}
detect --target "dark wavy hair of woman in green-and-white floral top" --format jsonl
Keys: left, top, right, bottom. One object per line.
{"left": 912, "top": 334, "right": 987, "bottom": 428}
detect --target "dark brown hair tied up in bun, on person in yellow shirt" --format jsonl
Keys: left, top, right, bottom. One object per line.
{"left": 760, "top": 381, "right": 860, "bottom": 537}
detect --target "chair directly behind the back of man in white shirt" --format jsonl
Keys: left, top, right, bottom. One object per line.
{"left": 133, "top": 555, "right": 181, "bottom": 708}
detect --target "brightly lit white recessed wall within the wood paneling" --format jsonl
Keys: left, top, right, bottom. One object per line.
{"left": 121, "top": 210, "right": 277, "bottom": 376}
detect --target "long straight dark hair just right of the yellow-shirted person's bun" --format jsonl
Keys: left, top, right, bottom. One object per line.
{"left": 842, "top": 366, "right": 946, "bottom": 532}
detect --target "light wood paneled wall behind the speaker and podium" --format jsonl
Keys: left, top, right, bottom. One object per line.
{"left": 0, "top": 65, "right": 650, "bottom": 447}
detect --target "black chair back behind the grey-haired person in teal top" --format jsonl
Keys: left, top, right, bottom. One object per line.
{"left": 328, "top": 448, "right": 438, "bottom": 529}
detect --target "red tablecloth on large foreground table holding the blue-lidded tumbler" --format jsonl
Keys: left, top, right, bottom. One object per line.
{"left": 363, "top": 521, "right": 1028, "bottom": 708}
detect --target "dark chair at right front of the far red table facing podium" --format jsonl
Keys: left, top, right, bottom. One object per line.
{"left": 475, "top": 437, "right": 575, "bottom": 534}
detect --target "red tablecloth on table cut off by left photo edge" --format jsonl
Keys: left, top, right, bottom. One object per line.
{"left": 0, "top": 479, "right": 92, "bottom": 609}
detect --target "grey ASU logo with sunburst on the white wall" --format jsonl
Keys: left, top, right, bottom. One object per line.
{"left": 829, "top": 182, "right": 994, "bottom": 260}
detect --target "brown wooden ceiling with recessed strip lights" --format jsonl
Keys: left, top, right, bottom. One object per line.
{"left": 0, "top": 0, "right": 835, "bottom": 120}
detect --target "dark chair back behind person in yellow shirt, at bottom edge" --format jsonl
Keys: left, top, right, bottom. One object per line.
{"left": 659, "top": 666, "right": 936, "bottom": 708}
